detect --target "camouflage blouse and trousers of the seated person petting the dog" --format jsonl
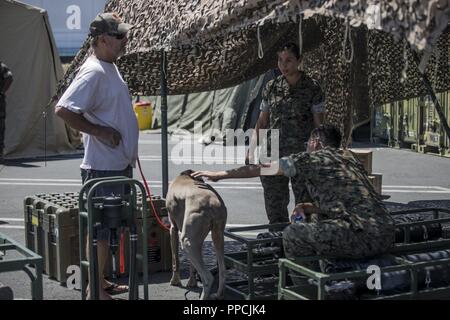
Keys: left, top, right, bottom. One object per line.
{"left": 280, "top": 147, "right": 395, "bottom": 258}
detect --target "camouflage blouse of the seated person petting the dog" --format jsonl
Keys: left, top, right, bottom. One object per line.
{"left": 280, "top": 148, "right": 394, "bottom": 237}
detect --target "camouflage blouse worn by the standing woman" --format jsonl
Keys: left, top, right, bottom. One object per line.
{"left": 261, "top": 72, "right": 325, "bottom": 157}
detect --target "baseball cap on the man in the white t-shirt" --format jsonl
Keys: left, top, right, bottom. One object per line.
{"left": 89, "top": 12, "right": 133, "bottom": 37}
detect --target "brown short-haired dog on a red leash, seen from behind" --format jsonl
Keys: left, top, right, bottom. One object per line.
{"left": 166, "top": 170, "right": 227, "bottom": 300}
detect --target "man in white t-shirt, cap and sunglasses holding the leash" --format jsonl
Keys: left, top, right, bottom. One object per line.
{"left": 55, "top": 13, "right": 139, "bottom": 299}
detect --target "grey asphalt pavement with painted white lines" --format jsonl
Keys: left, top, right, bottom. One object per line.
{"left": 0, "top": 132, "right": 450, "bottom": 300}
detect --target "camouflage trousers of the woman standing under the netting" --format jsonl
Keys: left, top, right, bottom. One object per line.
{"left": 261, "top": 176, "right": 307, "bottom": 224}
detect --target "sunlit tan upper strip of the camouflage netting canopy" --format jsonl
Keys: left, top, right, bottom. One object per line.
{"left": 115, "top": 0, "right": 449, "bottom": 50}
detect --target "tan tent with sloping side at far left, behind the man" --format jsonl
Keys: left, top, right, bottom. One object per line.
{"left": 0, "top": 0, "right": 79, "bottom": 159}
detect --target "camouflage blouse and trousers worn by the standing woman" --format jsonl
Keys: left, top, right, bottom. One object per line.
{"left": 261, "top": 71, "right": 325, "bottom": 224}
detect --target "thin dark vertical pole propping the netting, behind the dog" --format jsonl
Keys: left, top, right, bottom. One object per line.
{"left": 160, "top": 49, "right": 169, "bottom": 198}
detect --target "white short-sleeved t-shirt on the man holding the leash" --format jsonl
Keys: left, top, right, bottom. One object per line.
{"left": 57, "top": 55, "right": 139, "bottom": 170}
